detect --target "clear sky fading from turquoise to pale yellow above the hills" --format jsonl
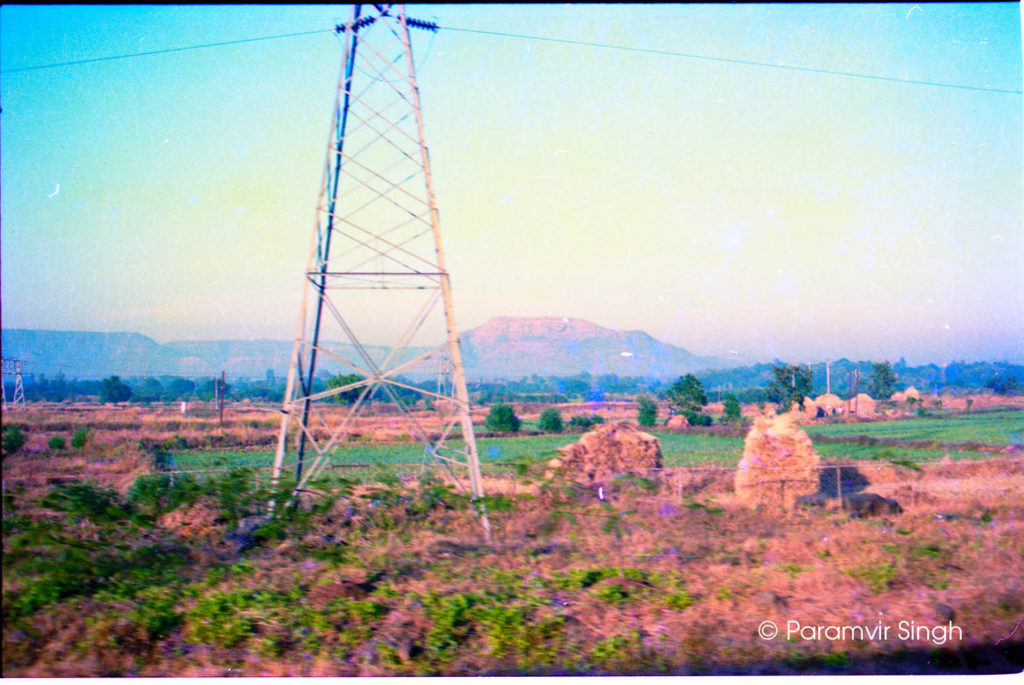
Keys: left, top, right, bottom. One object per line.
{"left": 0, "top": 3, "right": 1024, "bottom": 363}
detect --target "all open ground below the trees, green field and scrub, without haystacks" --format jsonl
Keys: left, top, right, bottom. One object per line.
{"left": 3, "top": 401, "right": 1024, "bottom": 677}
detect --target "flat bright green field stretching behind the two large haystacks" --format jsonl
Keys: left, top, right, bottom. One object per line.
{"left": 173, "top": 412, "right": 1024, "bottom": 475}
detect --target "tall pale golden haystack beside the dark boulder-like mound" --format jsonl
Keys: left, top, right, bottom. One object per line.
{"left": 735, "top": 415, "right": 821, "bottom": 509}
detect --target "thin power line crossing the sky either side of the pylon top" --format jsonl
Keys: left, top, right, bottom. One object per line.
{"left": 0, "top": 20, "right": 1024, "bottom": 95}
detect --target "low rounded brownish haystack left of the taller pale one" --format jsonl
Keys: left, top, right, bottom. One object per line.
{"left": 546, "top": 421, "right": 662, "bottom": 483}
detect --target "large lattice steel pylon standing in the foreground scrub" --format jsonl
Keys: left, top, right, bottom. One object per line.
{"left": 273, "top": 5, "right": 489, "bottom": 537}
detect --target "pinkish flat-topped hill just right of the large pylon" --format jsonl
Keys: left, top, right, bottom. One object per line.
{"left": 462, "top": 316, "right": 727, "bottom": 378}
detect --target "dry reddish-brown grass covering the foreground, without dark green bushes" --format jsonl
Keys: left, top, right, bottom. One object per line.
{"left": 3, "top": 401, "right": 1024, "bottom": 677}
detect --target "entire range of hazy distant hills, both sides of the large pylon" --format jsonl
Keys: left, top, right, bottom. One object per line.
{"left": 2, "top": 316, "right": 729, "bottom": 380}
